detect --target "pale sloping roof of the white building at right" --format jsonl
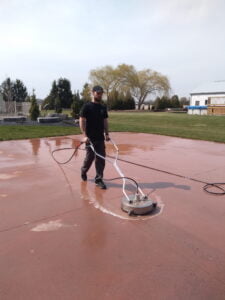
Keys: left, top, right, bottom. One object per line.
{"left": 190, "top": 80, "right": 225, "bottom": 95}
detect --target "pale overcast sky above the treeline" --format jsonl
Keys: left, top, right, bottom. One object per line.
{"left": 0, "top": 0, "right": 225, "bottom": 98}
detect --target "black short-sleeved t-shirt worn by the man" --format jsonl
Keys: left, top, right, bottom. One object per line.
{"left": 80, "top": 102, "right": 108, "bottom": 141}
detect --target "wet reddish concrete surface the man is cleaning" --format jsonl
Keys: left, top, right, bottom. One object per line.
{"left": 0, "top": 133, "right": 225, "bottom": 299}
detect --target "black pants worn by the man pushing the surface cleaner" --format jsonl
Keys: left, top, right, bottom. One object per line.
{"left": 81, "top": 141, "right": 105, "bottom": 181}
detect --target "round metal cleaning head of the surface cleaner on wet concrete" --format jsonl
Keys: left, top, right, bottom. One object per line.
{"left": 121, "top": 195, "right": 157, "bottom": 215}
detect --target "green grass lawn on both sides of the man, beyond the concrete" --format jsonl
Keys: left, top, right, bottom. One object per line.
{"left": 0, "top": 112, "right": 225, "bottom": 143}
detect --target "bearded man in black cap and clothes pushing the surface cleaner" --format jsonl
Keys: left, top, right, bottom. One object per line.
{"left": 79, "top": 85, "right": 110, "bottom": 189}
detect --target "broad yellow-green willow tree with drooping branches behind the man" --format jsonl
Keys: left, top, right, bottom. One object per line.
{"left": 90, "top": 64, "right": 170, "bottom": 109}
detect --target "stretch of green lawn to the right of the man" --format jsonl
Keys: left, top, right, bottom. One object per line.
{"left": 110, "top": 112, "right": 225, "bottom": 143}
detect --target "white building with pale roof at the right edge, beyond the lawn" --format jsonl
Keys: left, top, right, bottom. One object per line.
{"left": 188, "top": 80, "right": 225, "bottom": 115}
